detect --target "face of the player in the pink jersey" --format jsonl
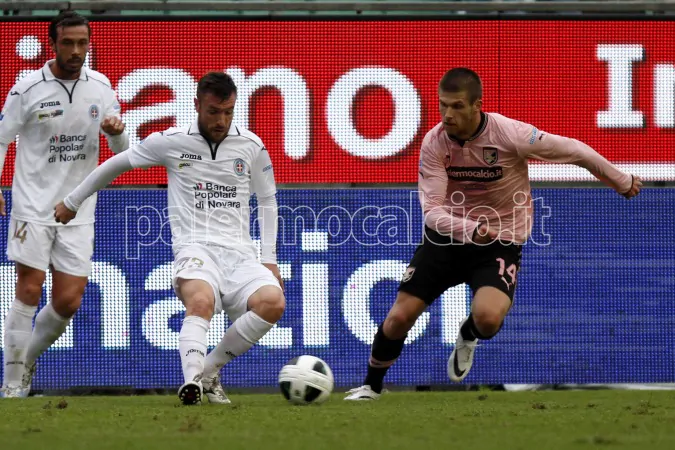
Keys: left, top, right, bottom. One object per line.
{"left": 438, "top": 89, "right": 482, "bottom": 139}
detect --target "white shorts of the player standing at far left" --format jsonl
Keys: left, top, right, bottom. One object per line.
{"left": 7, "top": 217, "right": 94, "bottom": 277}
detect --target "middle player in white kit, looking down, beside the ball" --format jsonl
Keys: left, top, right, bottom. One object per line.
{"left": 54, "top": 72, "right": 285, "bottom": 404}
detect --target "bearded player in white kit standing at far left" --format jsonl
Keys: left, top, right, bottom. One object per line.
{"left": 0, "top": 12, "right": 129, "bottom": 397}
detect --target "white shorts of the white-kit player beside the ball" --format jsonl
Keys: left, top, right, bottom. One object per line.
{"left": 173, "top": 244, "right": 281, "bottom": 322}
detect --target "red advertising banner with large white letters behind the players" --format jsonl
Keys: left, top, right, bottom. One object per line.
{"left": 0, "top": 20, "right": 675, "bottom": 185}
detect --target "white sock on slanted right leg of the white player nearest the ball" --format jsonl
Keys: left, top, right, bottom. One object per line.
{"left": 204, "top": 311, "right": 274, "bottom": 378}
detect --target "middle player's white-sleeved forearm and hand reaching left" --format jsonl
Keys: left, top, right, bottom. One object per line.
{"left": 54, "top": 152, "right": 133, "bottom": 224}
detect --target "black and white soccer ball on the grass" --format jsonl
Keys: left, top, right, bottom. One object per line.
{"left": 279, "top": 355, "right": 333, "bottom": 405}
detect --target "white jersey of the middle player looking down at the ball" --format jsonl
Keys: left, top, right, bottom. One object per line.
{"left": 127, "top": 120, "right": 276, "bottom": 258}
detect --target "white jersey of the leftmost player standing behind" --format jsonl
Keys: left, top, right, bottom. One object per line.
{"left": 0, "top": 61, "right": 120, "bottom": 226}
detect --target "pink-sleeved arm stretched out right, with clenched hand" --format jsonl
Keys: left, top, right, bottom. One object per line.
{"left": 512, "top": 121, "right": 642, "bottom": 198}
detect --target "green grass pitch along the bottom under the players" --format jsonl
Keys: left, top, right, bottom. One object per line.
{"left": 0, "top": 391, "right": 675, "bottom": 450}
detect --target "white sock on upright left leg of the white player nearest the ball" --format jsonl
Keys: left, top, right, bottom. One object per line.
{"left": 178, "top": 316, "right": 209, "bottom": 382}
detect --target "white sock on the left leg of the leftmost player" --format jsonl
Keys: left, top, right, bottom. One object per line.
{"left": 2, "top": 299, "right": 37, "bottom": 386}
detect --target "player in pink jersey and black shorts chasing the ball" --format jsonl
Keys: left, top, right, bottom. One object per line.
{"left": 345, "top": 68, "right": 642, "bottom": 400}
